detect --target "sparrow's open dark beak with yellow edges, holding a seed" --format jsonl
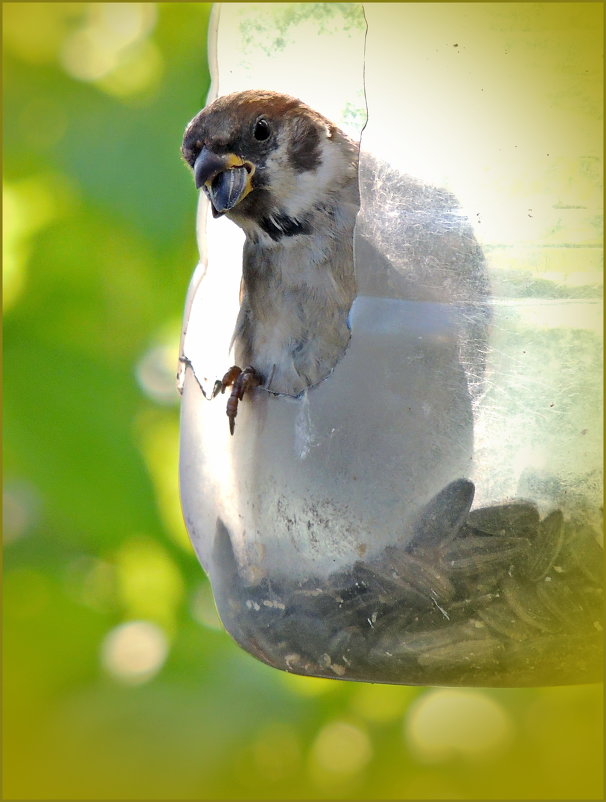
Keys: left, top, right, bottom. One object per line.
{"left": 194, "top": 147, "right": 255, "bottom": 217}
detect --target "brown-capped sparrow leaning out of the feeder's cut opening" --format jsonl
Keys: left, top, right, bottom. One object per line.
{"left": 181, "top": 90, "right": 360, "bottom": 434}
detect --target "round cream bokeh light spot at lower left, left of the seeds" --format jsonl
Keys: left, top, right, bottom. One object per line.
{"left": 101, "top": 621, "right": 168, "bottom": 685}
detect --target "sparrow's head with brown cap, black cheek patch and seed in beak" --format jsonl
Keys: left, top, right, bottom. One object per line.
{"left": 181, "top": 90, "right": 358, "bottom": 240}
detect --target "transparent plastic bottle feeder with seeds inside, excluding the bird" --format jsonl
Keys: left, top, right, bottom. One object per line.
{"left": 180, "top": 4, "right": 603, "bottom": 686}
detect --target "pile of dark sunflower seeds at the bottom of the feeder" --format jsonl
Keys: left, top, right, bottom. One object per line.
{"left": 213, "top": 480, "right": 603, "bottom": 686}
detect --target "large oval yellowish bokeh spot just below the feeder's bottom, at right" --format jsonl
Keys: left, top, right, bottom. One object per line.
{"left": 405, "top": 688, "right": 513, "bottom": 762}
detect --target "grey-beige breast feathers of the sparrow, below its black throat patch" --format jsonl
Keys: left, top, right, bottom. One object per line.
{"left": 234, "top": 227, "right": 355, "bottom": 395}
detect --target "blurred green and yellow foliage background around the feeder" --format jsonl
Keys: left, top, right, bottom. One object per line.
{"left": 3, "top": 3, "right": 602, "bottom": 799}
